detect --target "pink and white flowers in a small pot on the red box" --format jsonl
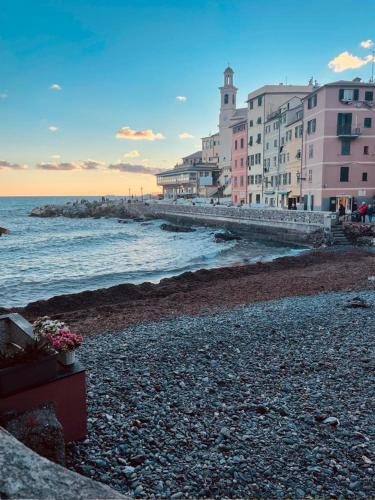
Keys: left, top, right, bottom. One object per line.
{"left": 34, "top": 317, "right": 83, "bottom": 365}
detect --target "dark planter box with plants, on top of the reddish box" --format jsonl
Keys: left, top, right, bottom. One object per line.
{"left": 0, "top": 354, "right": 57, "bottom": 397}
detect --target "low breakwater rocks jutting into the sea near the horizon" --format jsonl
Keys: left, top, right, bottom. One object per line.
{"left": 30, "top": 200, "right": 138, "bottom": 220}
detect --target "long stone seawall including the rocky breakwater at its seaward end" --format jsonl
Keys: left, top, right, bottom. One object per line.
{"left": 30, "top": 201, "right": 334, "bottom": 244}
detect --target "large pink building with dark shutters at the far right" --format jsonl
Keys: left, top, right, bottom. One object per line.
{"left": 301, "top": 78, "right": 375, "bottom": 211}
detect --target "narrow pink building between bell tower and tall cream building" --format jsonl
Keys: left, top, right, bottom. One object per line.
{"left": 231, "top": 119, "right": 248, "bottom": 204}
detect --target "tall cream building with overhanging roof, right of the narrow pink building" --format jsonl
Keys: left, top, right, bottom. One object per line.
{"left": 247, "top": 84, "right": 313, "bottom": 204}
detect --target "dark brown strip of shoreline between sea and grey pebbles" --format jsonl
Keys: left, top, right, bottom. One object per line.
{"left": 4, "top": 248, "right": 375, "bottom": 335}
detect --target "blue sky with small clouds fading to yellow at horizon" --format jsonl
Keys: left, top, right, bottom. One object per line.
{"left": 0, "top": 0, "right": 375, "bottom": 196}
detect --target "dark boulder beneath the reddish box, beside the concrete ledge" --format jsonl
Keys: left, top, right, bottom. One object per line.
{"left": 4, "top": 403, "right": 65, "bottom": 464}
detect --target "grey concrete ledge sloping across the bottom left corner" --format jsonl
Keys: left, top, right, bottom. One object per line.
{"left": 0, "top": 427, "right": 128, "bottom": 500}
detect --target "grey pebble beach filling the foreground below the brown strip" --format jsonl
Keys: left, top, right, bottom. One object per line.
{"left": 68, "top": 290, "right": 375, "bottom": 498}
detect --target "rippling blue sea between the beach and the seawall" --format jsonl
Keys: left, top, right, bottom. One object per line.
{"left": 0, "top": 196, "right": 303, "bottom": 307}
